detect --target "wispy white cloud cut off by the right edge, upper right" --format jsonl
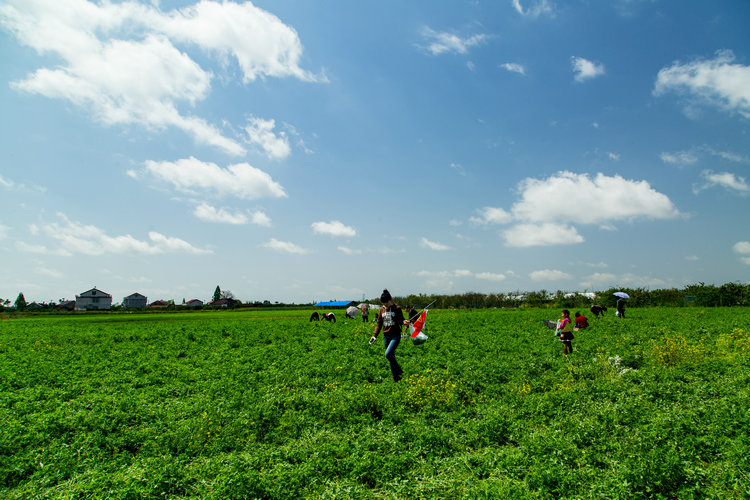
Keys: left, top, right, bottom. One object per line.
{"left": 654, "top": 50, "right": 750, "bottom": 118}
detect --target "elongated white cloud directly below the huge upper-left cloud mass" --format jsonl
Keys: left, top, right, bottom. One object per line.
{"left": 142, "top": 157, "right": 286, "bottom": 200}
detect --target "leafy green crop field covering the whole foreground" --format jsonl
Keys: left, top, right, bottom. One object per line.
{"left": 0, "top": 308, "right": 750, "bottom": 499}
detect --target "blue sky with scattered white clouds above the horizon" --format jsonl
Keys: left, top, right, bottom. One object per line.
{"left": 0, "top": 0, "right": 750, "bottom": 303}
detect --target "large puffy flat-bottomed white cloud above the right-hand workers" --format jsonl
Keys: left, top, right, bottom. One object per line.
{"left": 511, "top": 172, "right": 679, "bottom": 224}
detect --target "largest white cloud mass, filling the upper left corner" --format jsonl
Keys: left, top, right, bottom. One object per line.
{"left": 0, "top": 0, "right": 325, "bottom": 155}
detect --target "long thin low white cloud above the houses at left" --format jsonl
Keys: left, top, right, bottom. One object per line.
{"left": 28, "top": 214, "right": 213, "bottom": 256}
